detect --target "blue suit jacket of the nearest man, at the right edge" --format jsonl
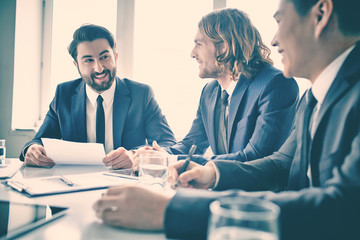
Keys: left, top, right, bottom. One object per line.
{"left": 164, "top": 42, "right": 360, "bottom": 240}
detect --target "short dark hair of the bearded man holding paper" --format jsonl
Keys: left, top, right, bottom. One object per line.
{"left": 68, "top": 24, "right": 115, "bottom": 62}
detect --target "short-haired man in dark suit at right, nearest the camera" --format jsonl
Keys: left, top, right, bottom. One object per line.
{"left": 94, "top": 0, "right": 360, "bottom": 240}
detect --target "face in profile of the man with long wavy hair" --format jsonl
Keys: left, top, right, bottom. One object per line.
{"left": 191, "top": 30, "right": 222, "bottom": 78}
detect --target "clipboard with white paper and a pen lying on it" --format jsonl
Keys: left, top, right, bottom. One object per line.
{"left": 5, "top": 172, "right": 138, "bottom": 197}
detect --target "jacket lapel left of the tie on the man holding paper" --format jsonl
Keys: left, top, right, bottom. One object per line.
{"left": 71, "top": 81, "right": 87, "bottom": 142}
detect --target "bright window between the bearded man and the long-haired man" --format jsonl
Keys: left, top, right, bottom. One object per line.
{"left": 132, "top": 0, "right": 213, "bottom": 140}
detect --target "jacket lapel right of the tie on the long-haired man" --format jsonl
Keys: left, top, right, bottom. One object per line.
{"left": 227, "top": 75, "right": 252, "bottom": 152}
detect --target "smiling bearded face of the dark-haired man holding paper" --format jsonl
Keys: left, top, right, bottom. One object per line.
{"left": 74, "top": 39, "right": 118, "bottom": 93}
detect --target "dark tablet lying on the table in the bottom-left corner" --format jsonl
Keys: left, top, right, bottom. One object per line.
{"left": 0, "top": 200, "right": 67, "bottom": 239}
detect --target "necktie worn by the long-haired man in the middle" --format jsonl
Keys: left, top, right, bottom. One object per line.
{"left": 216, "top": 90, "right": 229, "bottom": 154}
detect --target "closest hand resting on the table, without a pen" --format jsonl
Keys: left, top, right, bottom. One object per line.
{"left": 93, "top": 186, "right": 170, "bottom": 230}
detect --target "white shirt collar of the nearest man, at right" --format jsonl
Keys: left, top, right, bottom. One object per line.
{"left": 312, "top": 45, "right": 355, "bottom": 104}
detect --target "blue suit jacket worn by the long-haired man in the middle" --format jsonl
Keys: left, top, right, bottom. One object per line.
{"left": 169, "top": 64, "right": 299, "bottom": 164}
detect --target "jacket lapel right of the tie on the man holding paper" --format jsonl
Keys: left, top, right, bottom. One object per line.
{"left": 113, "top": 77, "right": 131, "bottom": 149}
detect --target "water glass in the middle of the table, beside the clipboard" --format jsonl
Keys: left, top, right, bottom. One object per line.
{"left": 139, "top": 154, "right": 168, "bottom": 189}
